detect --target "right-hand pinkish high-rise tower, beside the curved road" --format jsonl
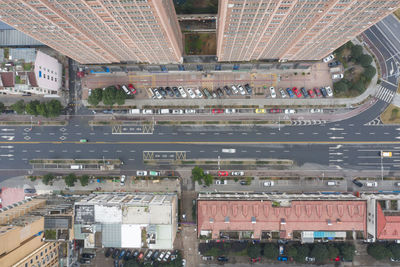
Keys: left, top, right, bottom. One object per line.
{"left": 217, "top": 0, "right": 400, "bottom": 61}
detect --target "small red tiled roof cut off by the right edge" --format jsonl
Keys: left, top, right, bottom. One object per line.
{"left": 376, "top": 203, "right": 400, "bottom": 240}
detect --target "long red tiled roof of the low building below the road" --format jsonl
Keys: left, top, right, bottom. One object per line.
{"left": 197, "top": 200, "right": 366, "bottom": 238}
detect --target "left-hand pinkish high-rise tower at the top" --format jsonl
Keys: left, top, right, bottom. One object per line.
{"left": 0, "top": 0, "right": 183, "bottom": 64}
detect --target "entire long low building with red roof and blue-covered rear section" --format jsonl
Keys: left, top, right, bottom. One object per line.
{"left": 197, "top": 193, "right": 367, "bottom": 242}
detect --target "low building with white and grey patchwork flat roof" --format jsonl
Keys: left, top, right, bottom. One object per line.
{"left": 74, "top": 193, "right": 178, "bottom": 249}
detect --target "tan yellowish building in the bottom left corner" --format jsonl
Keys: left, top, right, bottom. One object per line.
{"left": 0, "top": 199, "right": 59, "bottom": 267}
